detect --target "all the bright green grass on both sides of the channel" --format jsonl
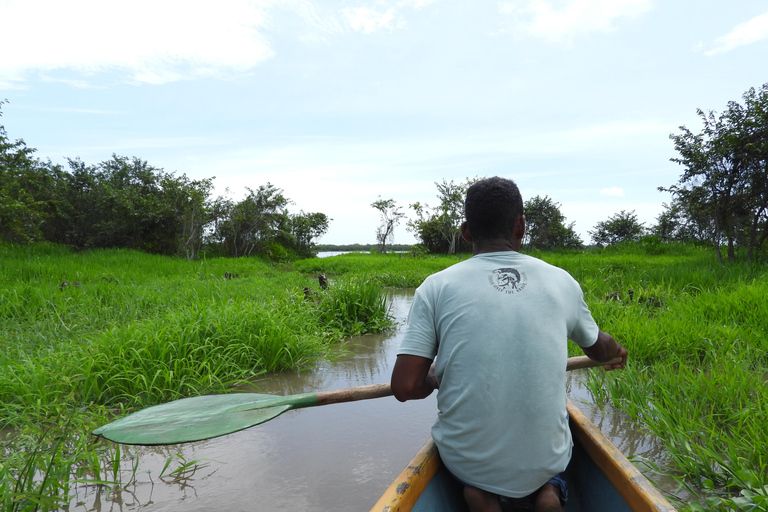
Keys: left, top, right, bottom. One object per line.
{"left": 0, "top": 245, "right": 768, "bottom": 510}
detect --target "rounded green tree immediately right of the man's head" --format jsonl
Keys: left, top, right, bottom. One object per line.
{"left": 523, "top": 196, "right": 584, "bottom": 250}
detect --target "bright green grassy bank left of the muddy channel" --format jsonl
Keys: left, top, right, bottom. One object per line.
{"left": 0, "top": 245, "right": 392, "bottom": 510}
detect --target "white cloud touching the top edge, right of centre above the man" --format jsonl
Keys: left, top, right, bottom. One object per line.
{"left": 499, "top": 0, "right": 652, "bottom": 43}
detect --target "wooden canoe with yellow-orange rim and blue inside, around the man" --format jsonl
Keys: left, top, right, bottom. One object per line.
{"left": 371, "top": 401, "right": 675, "bottom": 512}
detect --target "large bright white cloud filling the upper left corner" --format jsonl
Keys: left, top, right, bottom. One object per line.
{"left": 0, "top": 0, "right": 273, "bottom": 83}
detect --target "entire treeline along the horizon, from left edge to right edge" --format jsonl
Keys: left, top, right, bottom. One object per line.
{"left": 0, "top": 83, "right": 768, "bottom": 262}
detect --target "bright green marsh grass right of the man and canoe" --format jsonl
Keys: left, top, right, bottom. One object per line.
{"left": 543, "top": 246, "right": 768, "bottom": 510}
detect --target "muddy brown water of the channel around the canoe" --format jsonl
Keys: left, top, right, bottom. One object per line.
{"left": 75, "top": 290, "right": 674, "bottom": 512}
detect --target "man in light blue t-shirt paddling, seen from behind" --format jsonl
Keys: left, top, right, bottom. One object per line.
{"left": 392, "top": 177, "right": 627, "bottom": 512}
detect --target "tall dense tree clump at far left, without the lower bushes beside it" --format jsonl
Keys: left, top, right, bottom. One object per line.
{"left": 0, "top": 113, "right": 222, "bottom": 258}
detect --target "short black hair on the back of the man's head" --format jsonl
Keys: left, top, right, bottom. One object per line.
{"left": 464, "top": 176, "right": 523, "bottom": 240}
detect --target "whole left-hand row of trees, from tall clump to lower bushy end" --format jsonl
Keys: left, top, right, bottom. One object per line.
{"left": 0, "top": 102, "right": 329, "bottom": 259}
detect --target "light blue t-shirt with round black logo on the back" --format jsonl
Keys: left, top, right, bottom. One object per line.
{"left": 398, "top": 251, "right": 598, "bottom": 497}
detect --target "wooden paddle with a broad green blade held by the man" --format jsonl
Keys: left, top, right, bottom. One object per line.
{"left": 93, "top": 356, "right": 618, "bottom": 445}
